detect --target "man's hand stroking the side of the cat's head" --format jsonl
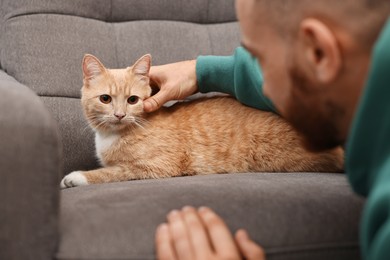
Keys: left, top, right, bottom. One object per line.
{"left": 144, "top": 60, "right": 198, "bottom": 112}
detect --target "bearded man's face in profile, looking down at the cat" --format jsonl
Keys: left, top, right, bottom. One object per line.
{"left": 236, "top": 0, "right": 345, "bottom": 150}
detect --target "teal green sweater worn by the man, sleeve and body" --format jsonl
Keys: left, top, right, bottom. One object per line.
{"left": 196, "top": 18, "right": 390, "bottom": 260}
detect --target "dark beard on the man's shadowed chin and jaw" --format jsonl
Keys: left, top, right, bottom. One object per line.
{"left": 284, "top": 66, "right": 345, "bottom": 152}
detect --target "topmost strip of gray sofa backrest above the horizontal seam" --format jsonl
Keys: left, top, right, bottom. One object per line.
{"left": 1, "top": 0, "right": 236, "bottom": 24}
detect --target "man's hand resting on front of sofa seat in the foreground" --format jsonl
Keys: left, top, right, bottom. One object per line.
{"left": 156, "top": 207, "right": 265, "bottom": 260}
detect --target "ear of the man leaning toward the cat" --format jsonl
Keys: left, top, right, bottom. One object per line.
{"left": 299, "top": 18, "right": 342, "bottom": 84}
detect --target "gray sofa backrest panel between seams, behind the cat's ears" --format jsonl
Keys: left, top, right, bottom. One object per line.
{"left": 1, "top": 14, "right": 239, "bottom": 97}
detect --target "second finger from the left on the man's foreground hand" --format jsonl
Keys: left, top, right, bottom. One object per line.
{"left": 168, "top": 210, "right": 194, "bottom": 259}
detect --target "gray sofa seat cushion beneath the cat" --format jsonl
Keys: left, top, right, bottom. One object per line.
{"left": 58, "top": 173, "right": 362, "bottom": 260}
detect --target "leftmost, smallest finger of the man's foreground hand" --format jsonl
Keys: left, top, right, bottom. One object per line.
{"left": 155, "top": 224, "right": 177, "bottom": 260}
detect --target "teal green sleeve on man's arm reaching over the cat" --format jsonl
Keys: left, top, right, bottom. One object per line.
{"left": 196, "top": 47, "right": 276, "bottom": 113}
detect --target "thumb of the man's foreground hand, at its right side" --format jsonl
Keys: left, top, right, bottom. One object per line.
{"left": 235, "top": 229, "right": 265, "bottom": 260}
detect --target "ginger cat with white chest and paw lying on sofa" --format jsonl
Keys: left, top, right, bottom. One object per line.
{"left": 60, "top": 55, "right": 344, "bottom": 188}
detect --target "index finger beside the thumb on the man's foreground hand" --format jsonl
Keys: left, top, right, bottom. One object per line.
{"left": 199, "top": 207, "right": 239, "bottom": 258}
